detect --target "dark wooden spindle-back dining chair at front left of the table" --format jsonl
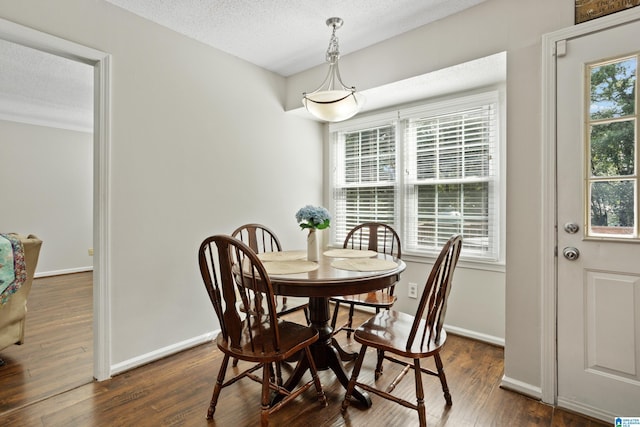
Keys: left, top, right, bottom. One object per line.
{"left": 198, "top": 235, "right": 327, "bottom": 426}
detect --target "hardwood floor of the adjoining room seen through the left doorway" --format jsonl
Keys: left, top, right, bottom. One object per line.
{"left": 0, "top": 272, "right": 93, "bottom": 414}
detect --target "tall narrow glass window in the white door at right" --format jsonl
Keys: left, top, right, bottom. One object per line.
{"left": 585, "top": 55, "right": 639, "bottom": 239}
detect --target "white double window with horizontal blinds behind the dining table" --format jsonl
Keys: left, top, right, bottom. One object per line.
{"left": 330, "top": 92, "right": 501, "bottom": 262}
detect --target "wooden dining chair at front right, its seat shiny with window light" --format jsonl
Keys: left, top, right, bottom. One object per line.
{"left": 342, "top": 235, "right": 462, "bottom": 426}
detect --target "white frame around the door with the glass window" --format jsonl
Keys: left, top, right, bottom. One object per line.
{"left": 540, "top": 7, "right": 640, "bottom": 418}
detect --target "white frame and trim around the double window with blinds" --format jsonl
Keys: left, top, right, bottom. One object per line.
{"left": 328, "top": 88, "right": 506, "bottom": 271}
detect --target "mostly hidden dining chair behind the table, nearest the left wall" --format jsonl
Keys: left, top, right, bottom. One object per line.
{"left": 231, "top": 224, "right": 311, "bottom": 325}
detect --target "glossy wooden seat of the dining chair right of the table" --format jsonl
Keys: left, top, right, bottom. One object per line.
{"left": 353, "top": 310, "right": 447, "bottom": 359}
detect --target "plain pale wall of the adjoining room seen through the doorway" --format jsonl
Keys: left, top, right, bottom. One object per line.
{"left": 0, "top": 120, "right": 93, "bottom": 276}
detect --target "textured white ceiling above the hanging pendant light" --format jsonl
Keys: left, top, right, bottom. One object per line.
{"left": 107, "top": 0, "right": 485, "bottom": 76}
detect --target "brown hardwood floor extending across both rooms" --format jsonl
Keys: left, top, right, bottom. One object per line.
{"left": 0, "top": 274, "right": 610, "bottom": 427}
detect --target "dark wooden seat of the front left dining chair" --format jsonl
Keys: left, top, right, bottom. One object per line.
{"left": 217, "top": 315, "right": 318, "bottom": 363}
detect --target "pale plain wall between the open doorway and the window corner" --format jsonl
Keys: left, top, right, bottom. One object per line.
{"left": 0, "top": 0, "right": 322, "bottom": 365}
